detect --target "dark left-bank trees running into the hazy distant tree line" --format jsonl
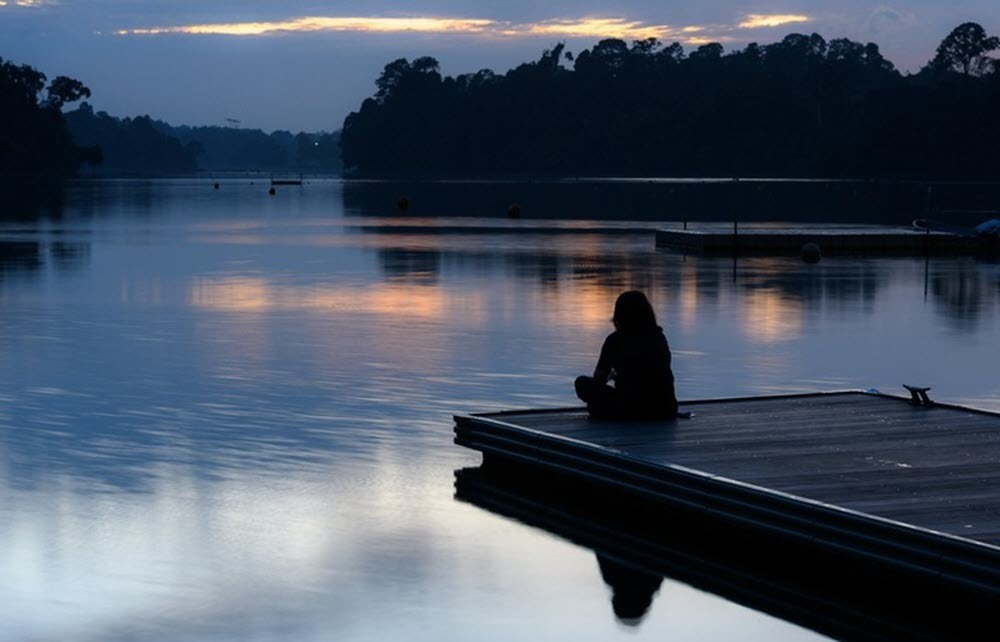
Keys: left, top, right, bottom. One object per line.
{"left": 0, "top": 58, "right": 340, "bottom": 179}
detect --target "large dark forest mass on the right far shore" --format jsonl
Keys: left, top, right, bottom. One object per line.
{"left": 341, "top": 23, "right": 1000, "bottom": 179}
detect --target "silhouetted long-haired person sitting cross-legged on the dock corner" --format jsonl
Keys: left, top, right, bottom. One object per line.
{"left": 576, "top": 290, "right": 677, "bottom": 419}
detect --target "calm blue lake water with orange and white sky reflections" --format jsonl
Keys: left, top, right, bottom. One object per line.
{"left": 0, "top": 179, "right": 1000, "bottom": 641}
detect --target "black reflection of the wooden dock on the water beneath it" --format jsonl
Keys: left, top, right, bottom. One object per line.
{"left": 455, "top": 467, "right": 980, "bottom": 642}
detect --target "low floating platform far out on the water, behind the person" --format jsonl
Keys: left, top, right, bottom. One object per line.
{"left": 656, "top": 224, "right": 1000, "bottom": 256}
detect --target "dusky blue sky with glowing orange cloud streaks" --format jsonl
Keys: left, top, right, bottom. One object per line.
{"left": 0, "top": 0, "right": 1000, "bottom": 131}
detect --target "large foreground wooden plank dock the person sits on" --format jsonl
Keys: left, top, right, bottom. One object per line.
{"left": 455, "top": 391, "right": 1000, "bottom": 608}
